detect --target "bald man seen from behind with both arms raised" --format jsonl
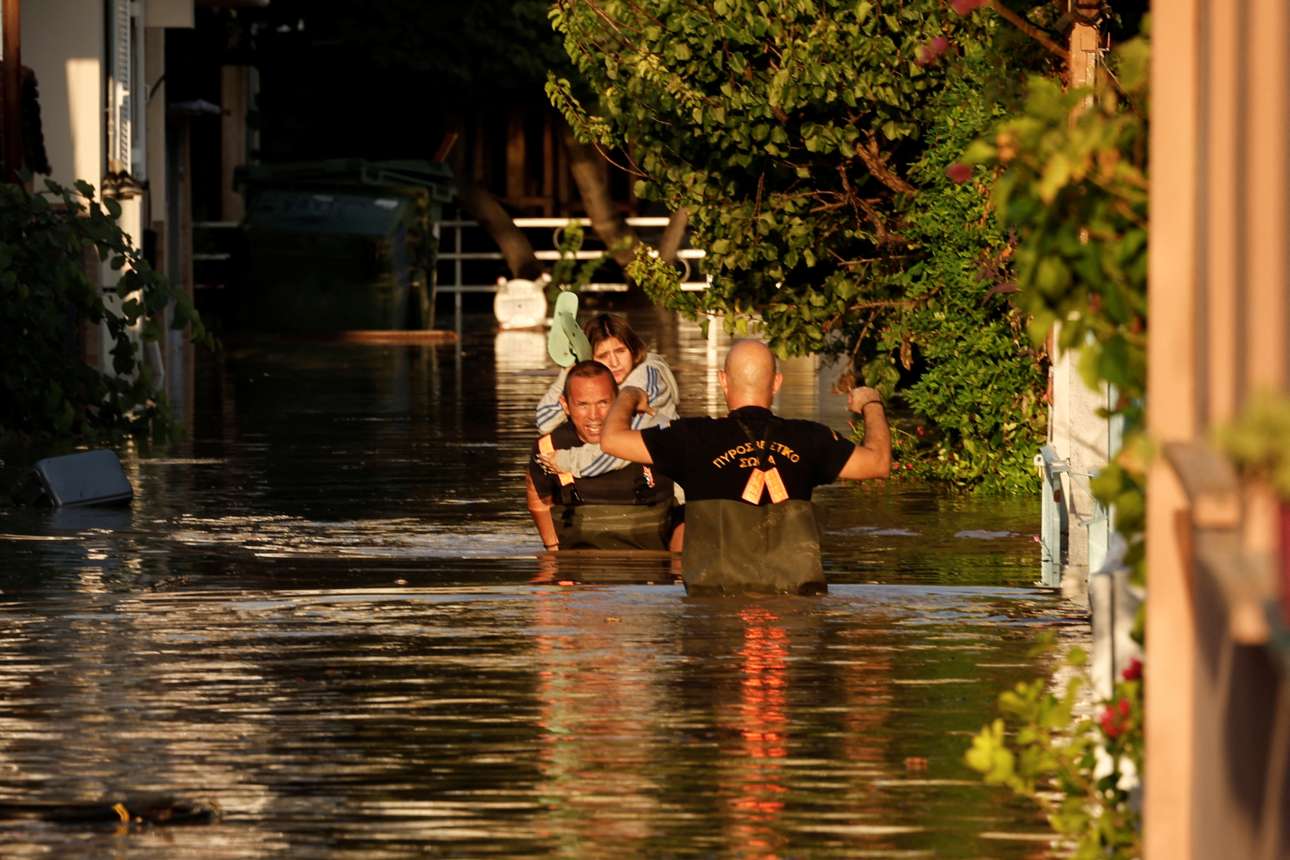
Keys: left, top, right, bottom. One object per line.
{"left": 600, "top": 340, "right": 891, "bottom": 593}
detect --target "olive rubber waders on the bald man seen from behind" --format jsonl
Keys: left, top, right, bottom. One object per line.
{"left": 681, "top": 499, "right": 828, "bottom": 594}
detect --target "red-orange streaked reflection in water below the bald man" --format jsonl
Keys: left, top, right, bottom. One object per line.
{"left": 662, "top": 596, "right": 825, "bottom": 857}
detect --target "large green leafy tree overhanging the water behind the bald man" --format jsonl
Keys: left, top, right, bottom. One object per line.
{"left": 547, "top": 0, "right": 1044, "bottom": 489}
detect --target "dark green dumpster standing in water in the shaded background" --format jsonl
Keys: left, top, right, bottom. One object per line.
{"left": 237, "top": 160, "right": 452, "bottom": 333}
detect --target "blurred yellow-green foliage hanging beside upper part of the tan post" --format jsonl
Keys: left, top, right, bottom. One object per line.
{"left": 964, "top": 30, "right": 1149, "bottom": 562}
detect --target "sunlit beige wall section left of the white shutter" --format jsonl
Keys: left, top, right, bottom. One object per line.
{"left": 22, "top": 0, "right": 106, "bottom": 188}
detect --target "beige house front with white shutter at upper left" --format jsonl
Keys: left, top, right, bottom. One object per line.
{"left": 20, "top": 0, "right": 203, "bottom": 406}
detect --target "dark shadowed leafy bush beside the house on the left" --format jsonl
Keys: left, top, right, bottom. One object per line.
{"left": 0, "top": 182, "right": 205, "bottom": 441}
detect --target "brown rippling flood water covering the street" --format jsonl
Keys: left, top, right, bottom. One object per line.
{"left": 0, "top": 317, "right": 1084, "bottom": 859}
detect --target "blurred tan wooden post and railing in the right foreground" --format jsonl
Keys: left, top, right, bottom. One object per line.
{"left": 1144, "top": 0, "right": 1290, "bottom": 860}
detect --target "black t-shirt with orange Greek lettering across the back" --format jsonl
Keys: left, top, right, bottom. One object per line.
{"left": 641, "top": 406, "right": 855, "bottom": 504}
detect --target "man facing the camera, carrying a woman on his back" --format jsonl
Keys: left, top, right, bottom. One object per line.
{"left": 526, "top": 361, "right": 673, "bottom": 551}
